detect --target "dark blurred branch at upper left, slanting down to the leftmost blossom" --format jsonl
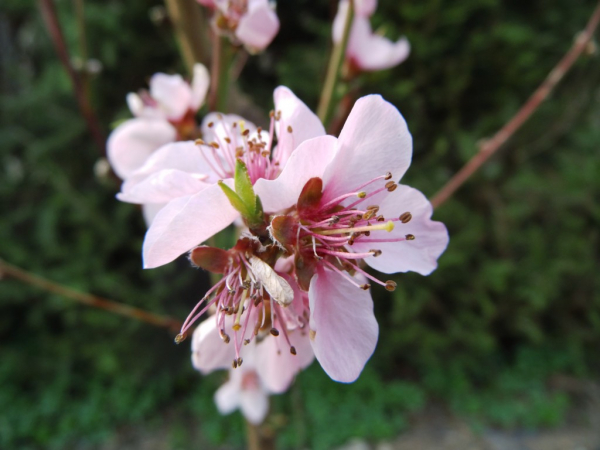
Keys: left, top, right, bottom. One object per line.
{"left": 38, "top": 0, "right": 106, "bottom": 155}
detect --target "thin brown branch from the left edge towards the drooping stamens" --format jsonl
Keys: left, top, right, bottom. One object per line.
{"left": 0, "top": 259, "right": 182, "bottom": 332}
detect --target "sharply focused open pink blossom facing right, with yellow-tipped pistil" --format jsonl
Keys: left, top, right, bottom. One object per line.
{"left": 255, "top": 95, "right": 448, "bottom": 382}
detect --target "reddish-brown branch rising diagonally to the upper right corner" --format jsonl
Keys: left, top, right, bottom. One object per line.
{"left": 431, "top": 2, "right": 600, "bottom": 208}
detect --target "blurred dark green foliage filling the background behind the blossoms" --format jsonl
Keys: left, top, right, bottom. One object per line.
{"left": 0, "top": 0, "right": 600, "bottom": 449}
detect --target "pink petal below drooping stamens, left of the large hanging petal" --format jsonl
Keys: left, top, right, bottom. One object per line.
{"left": 254, "top": 329, "right": 314, "bottom": 394}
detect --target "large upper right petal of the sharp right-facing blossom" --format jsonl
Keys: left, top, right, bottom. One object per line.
{"left": 323, "top": 95, "right": 412, "bottom": 205}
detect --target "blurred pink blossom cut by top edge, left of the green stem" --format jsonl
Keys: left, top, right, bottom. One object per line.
{"left": 198, "top": 0, "right": 279, "bottom": 53}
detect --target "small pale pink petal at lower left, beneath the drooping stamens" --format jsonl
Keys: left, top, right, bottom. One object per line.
{"left": 192, "top": 316, "right": 235, "bottom": 375}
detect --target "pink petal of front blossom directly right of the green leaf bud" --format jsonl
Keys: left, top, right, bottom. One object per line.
{"left": 254, "top": 136, "right": 337, "bottom": 212}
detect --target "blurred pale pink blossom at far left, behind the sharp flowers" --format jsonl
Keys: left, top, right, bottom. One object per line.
{"left": 107, "top": 64, "right": 209, "bottom": 180}
